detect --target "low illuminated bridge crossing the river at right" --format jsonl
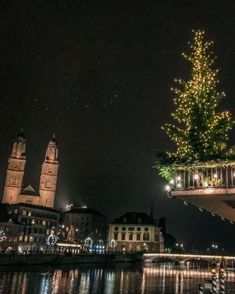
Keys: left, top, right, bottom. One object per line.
{"left": 143, "top": 253, "right": 235, "bottom": 267}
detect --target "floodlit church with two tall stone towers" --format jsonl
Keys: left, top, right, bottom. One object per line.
{"left": 2, "top": 132, "right": 59, "bottom": 208}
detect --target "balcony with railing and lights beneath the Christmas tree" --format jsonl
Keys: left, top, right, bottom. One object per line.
{"left": 166, "top": 162, "right": 235, "bottom": 222}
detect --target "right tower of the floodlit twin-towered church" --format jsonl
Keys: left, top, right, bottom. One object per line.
{"left": 39, "top": 135, "right": 59, "bottom": 208}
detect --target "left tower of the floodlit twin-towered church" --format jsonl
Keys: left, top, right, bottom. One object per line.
{"left": 2, "top": 131, "right": 26, "bottom": 204}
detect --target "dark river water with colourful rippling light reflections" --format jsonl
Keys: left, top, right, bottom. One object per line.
{"left": 0, "top": 264, "right": 235, "bottom": 294}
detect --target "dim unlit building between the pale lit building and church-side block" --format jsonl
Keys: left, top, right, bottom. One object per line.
{"left": 62, "top": 207, "right": 107, "bottom": 243}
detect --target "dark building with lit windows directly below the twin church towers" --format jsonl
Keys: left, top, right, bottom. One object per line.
{"left": 0, "top": 203, "right": 60, "bottom": 250}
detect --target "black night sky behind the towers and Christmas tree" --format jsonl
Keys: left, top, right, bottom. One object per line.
{"left": 0, "top": 0, "right": 235, "bottom": 248}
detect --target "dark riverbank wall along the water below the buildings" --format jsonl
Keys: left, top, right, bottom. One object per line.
{"left": 0, "top": 252, "right": 143, "bottom": 266}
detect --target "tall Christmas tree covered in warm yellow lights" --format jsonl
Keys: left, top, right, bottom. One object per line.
{"left": 163, "top": 30, "right": 234, "bottom": 162}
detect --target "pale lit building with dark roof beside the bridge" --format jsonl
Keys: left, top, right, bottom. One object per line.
{"left": 108, "top": 212, "right": 164, "bottom": 252}
